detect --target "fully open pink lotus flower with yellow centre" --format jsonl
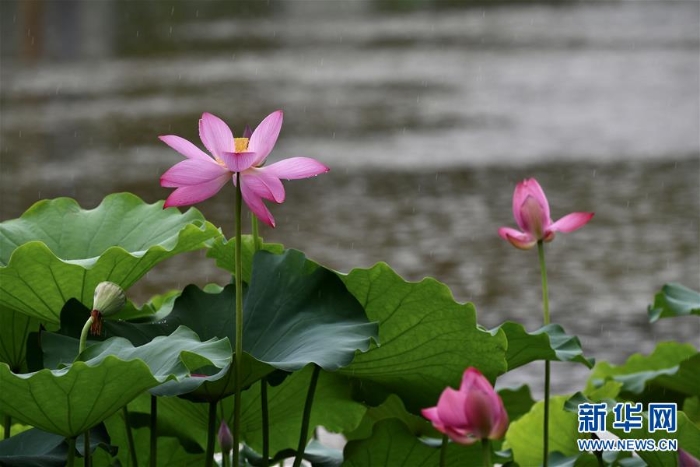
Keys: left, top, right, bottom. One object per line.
{"left": 159, "top": 110, "right": 330, "bottom": 227}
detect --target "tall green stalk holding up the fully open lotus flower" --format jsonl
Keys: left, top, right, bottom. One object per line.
{"left": 233, "top": 172, "right": 243, "bottom": 467}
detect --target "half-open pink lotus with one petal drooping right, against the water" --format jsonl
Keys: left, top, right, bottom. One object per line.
{"left": 498, "top": 178, "right": 593, "bottom": 250}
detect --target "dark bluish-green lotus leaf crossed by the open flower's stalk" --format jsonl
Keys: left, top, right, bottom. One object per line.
{"left": 97, "top": 250, "right": 377, "bottom": 371}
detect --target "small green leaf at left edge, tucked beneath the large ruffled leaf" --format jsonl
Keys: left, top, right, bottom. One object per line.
{"left": 0, "top": 305, "right": 40, "bottom": 373}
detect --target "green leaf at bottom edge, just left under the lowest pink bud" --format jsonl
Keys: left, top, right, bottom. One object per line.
{"left": 343, "top": 418, "right": 483, "bottom": 467}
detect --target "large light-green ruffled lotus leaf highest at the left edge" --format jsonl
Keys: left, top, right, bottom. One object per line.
{"left": 0, "top": 193, "right": 221, "bottom": 323}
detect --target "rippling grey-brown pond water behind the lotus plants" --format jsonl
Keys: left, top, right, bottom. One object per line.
{"left": 0, "top": 0, "right": 700, "bottom": 393}
